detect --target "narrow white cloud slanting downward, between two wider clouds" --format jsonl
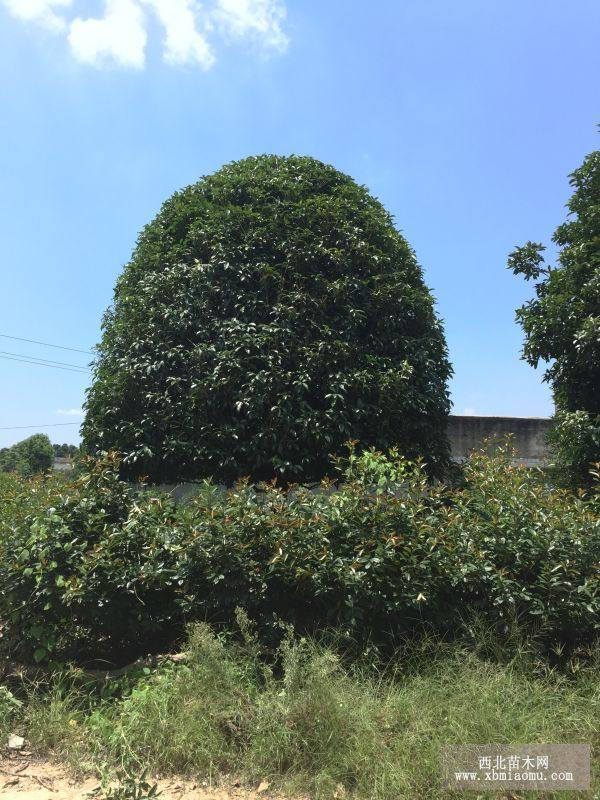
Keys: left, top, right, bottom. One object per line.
{"left": 142, "top": 0, "right": 215, "bottom": 69}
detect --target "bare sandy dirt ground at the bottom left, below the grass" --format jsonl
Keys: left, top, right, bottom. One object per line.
{"left": 0, "top": 757, "right": 282, "bottom": 800}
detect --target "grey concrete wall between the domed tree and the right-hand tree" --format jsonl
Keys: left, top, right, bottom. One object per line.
{"left": 448, "top": 416, "right": 552, "bottom": 466}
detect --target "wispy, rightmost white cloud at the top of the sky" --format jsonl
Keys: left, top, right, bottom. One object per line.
{"left": 213, "top": 0, "right": 289, "bottom": 52}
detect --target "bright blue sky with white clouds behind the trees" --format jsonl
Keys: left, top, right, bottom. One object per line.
{"left": 0, "top": 0, "right": 600, "bottom": 446}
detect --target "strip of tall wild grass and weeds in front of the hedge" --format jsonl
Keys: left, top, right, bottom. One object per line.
{"left": 0, "top": 618, "right": 600, "bottom": 800}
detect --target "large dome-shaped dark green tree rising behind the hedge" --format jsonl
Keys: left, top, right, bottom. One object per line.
{"left": 83, "top": 156, "right": 450, "bottom": 483}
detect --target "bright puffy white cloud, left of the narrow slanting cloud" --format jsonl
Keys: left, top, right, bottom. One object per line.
{"left": 69, "top": 0, "right": 148, "bottom": 69}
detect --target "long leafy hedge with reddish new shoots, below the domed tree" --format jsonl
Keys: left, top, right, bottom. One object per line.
{"left": 0, "top": 451, "right": 600, "bottom": 661}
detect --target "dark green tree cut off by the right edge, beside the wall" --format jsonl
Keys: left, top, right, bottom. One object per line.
{"left": 509, "top": 150, "right": 600, "bottom": 485}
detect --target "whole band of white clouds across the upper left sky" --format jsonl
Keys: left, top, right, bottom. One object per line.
{"left": 0, "top": 0, "right": 288, "bottom": 69}
